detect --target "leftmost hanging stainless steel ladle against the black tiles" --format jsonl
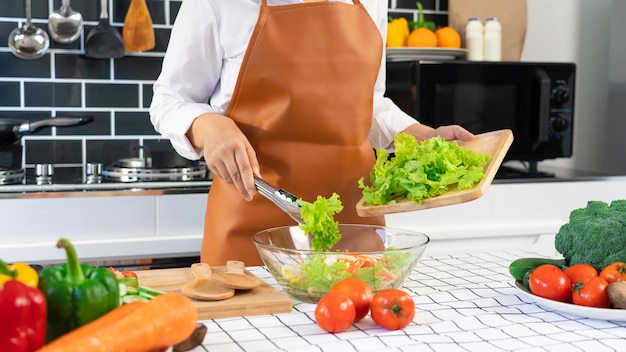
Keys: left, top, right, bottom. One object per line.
{"left": 9, "top": 0, "right": 50, "bottom": 60}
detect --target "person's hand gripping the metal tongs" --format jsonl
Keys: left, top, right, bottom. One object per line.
{"left": 187, "top": 113, "right": 260, "bottom": 200}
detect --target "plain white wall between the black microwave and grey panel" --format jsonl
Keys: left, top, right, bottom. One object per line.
{"left": 522, "top": 0, "right": 608, "bottom": 172}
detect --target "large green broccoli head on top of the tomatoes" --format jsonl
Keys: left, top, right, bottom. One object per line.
{"left": 554, "top": 200, "right": 626, "bottom": 270}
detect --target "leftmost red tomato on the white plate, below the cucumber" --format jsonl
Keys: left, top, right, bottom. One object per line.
{"left": 528, "top": 264, "right": 572, "bottom": 302}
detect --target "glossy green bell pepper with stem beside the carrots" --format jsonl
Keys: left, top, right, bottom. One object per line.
{"left": 39, "top": 238, "right": 120, "bottom": 342}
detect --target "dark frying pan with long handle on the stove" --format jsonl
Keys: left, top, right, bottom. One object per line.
{"left": 0, "top": 116, "right": 93, "bottom": 146}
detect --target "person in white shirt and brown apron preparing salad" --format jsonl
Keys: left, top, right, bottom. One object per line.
{"left": 150, "top": 0, "right": 473, "bottom": 265}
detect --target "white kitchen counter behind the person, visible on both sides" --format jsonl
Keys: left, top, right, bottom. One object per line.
{"left": 0, "top": 176, "right": 626, "bottom": 265}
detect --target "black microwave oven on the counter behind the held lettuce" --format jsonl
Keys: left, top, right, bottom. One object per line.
{"left": 386, "top": 60, "right": 576, "bottom": 175}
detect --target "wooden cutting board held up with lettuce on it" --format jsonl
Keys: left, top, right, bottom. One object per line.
{"left": 356, "top": 129, "right": 513, "bottom": 217}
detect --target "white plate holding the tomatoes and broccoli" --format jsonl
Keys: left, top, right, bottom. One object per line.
{"left": 515, "top": 281, "right": 626, "bottom": 321}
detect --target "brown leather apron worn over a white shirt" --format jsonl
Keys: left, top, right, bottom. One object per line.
{"left": 201, "top": 0, "right": 384, "bottom": 265}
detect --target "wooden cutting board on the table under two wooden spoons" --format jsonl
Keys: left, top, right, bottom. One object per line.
{"left": 136, "top": 266, "right": 292, "bottom": 320}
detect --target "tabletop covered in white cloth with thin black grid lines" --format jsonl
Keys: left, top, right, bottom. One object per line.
{"left": 192, "top": 247, "right": 626, "bottom": 352}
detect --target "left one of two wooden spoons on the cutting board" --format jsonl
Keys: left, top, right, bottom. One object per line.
{"left": 181, "top": 263, "right": 235, "bottom": 301}
